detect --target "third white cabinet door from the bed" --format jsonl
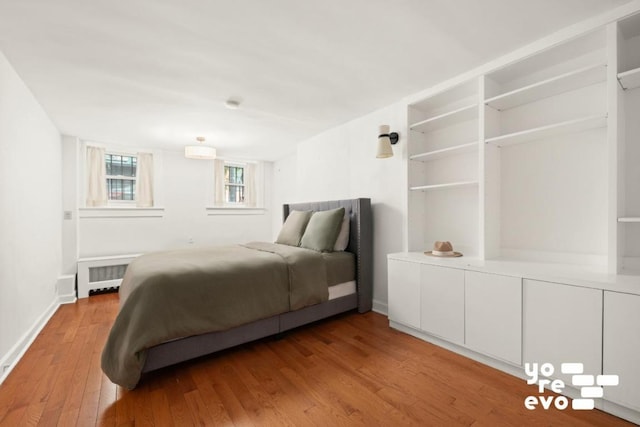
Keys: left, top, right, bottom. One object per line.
{"left": 465, "top": 271, "right": 522, "bottom": 365}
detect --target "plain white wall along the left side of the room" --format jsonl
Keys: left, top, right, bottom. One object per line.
{"left": 0, "top": 53, "right": 62, "bottom": 368}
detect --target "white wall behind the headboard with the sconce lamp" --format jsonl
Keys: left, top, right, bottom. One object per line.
{"left": 273, "top": 102, "right": 407, "bottom": 312}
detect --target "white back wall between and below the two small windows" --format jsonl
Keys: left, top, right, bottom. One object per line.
{"left": 78, "top": 151, "right": 273, "bottom": 258}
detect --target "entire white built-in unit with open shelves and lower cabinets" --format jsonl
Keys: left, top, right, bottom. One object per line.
{"left": 396, "top": 7, "right": 640, "bottom": 422}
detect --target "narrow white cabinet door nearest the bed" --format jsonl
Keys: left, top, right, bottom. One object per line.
{"left": 388, "top": 259, "right": 420, "bottom": 329}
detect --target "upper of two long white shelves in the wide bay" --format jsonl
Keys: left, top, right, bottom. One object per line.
{"left": 484, "top": 64, "right": 607, "bottom": 110}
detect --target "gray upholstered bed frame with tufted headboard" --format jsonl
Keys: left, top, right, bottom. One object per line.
{"left": 142, "top": 199, "right": 373, "bottom": 373}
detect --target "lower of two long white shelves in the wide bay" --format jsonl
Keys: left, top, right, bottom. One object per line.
{"left": 485, "top": 115, "right": 607, "bottom": 147}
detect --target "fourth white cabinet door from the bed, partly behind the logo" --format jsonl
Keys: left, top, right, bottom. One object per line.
{"left": 523, "top": 279, "right": 602, "bottom": 385}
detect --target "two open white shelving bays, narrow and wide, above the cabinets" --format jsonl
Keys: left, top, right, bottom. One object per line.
{"left": 408, "top": 25, "right": 612, "bottom": 267}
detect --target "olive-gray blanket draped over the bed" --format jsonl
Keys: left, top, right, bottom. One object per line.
{"left": 102, "top": 242, "right": 329, "bottom": 389}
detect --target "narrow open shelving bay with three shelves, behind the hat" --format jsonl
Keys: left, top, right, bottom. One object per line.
{"left": 408, "top": 79, "right": 481, "bottom": 254}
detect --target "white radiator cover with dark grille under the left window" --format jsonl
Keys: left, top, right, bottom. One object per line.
{"left": 78, "top": 254, "right": 140, "bottom": 298}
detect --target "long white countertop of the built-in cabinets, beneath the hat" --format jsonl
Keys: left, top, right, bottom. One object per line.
{"left": 387, "top": 252, "right": 640, "bottom": 295}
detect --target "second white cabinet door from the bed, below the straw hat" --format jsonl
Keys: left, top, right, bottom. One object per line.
{"left": 420, "top": 265, "right": 464, "bottom": 344}
